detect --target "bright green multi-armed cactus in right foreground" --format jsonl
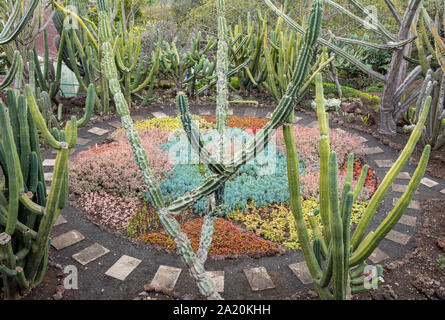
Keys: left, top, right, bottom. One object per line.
{"left": 283, "top": 75, "right": 431, "bottom": 300}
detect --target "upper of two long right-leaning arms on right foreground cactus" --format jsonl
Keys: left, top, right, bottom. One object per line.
{"left": 351, "top": 97, "right": 431, "bottom": 249}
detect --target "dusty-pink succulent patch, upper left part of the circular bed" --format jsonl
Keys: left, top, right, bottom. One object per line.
{"left": 70, "top": 128, "right": 172, "bottom": 199}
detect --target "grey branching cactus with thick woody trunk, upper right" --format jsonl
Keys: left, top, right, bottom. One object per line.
{"left": 264, "top": 0, "right": 422, "bottom": 134}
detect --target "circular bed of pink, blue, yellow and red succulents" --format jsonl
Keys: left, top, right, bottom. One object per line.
{"left": 70, "top": 116, "right": 377, "bottom": 258}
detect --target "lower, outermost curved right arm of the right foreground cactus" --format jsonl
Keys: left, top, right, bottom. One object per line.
{"left": 349, "top": 145, "right": 431, "bottom": 266}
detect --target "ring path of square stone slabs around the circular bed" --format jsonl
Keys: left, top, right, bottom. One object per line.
{"left": 39, "top": 106, "right": 445, "bottom": 299}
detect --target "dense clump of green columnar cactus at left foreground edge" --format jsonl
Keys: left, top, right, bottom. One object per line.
{"left": 0, "top": 85, "right": 77, "bottom": 299}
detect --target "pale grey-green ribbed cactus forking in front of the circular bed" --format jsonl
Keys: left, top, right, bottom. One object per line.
{"left": 98, "top": 0, "right": 322, "bottom": 299}
